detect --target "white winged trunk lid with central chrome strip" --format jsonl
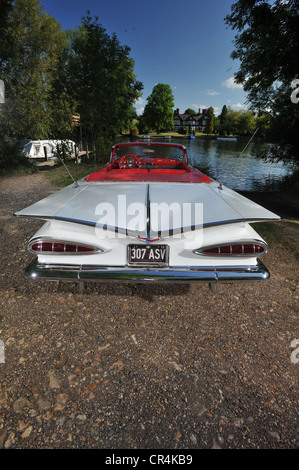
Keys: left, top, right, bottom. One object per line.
{"left": 15, "top": 181, "right": 280, "bottom": 238}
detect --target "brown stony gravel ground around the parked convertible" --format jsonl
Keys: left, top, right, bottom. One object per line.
{"left": 0, "top": 173, "right": 299, "bottom": 449}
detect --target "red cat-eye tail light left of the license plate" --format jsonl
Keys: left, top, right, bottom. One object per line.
{"left": 28, "top": 239, "right": 103, "bottom": 255}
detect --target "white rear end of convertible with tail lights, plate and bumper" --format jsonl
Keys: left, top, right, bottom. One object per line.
{"left": 22, "top": 203, "right": 269, "bottom": 285}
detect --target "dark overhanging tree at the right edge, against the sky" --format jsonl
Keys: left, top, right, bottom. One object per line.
{"left": 226, "top": 0, "right": 299, "bottom": 160}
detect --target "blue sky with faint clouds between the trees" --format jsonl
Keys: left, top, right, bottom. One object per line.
{"left": 41, "top": 0, "right": 247, "bottom": 115}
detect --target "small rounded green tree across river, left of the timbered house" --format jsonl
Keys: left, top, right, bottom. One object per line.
{"left": 143, "top": 83, "right": 174, "bottom": 132}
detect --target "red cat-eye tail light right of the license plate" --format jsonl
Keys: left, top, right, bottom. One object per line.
{"left": 193, "top": 241, "right": 268, "bottom": 257}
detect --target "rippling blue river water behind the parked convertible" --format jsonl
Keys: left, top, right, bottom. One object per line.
{"left": 123, "top": 137, "right": 293, "bottom": 191}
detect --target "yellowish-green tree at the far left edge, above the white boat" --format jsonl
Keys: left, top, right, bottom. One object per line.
{"left": 0, "top": 0, "right": 66, "bottom": 138}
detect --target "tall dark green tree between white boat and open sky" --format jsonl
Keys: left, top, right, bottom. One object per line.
{"left": 66, "top": 16, "right": 143, "bottom": 158}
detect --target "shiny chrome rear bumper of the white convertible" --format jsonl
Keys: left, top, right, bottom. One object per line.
{"left": 26, "top": 259, "right": 270, "bottom": 282}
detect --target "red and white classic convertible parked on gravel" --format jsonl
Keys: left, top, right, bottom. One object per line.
{"left": 16, "top": 142, "right": 279, "bottom": 287}
